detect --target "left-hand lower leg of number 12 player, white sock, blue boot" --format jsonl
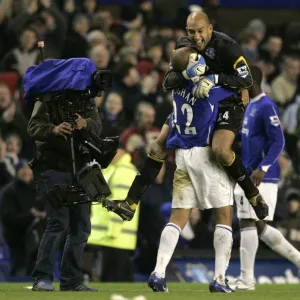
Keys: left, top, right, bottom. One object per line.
{"left": 148, "top": 208, "right": 191, "bottom": 292}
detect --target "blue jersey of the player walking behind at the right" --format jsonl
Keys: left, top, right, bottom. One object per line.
{"left": 242, "top": 93, "right": 285, "bottom": 183}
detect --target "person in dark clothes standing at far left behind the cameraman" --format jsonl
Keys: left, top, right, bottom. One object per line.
{"left": 0, "top": 161, "right": 46, "bottom": 276}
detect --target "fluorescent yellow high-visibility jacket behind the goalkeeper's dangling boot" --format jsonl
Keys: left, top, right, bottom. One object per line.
{"left": 88, "top": 153, "right": 139, "bottom": 250}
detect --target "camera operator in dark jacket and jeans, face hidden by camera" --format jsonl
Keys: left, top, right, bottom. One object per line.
{"left": 28, "top": 95, "right": 102, "bottom": 291}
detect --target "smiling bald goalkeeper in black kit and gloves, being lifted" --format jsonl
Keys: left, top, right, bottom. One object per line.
{"left": 104, "top": 12, "right": 268, "bottom": 220}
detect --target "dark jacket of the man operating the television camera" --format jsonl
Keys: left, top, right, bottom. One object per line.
{"left": 27, "top": 100, "right": 102, "bottom": 172}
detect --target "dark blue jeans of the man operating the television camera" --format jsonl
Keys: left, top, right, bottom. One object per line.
{"left": 32, "top": 170, "right": 91, "bottom": 288}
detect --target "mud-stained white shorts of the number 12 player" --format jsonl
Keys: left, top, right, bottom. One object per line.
{"left": 172, "top": 147, "right": 234, "bottom": 210}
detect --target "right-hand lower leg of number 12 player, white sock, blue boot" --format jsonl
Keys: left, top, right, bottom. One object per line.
{"left": 209, "top": 206, "right": 234, "bottom": 293}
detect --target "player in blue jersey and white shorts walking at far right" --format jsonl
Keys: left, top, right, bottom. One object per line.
{"left": 235, "top": 66, "right": 300, "bottom": 290}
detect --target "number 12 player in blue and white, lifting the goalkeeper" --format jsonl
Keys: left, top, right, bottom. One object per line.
{"left": 152, "top": 47, "right": 234, "bottom": 293}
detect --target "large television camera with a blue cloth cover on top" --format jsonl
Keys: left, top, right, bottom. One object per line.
{"left": 24, "top": 47, "right": 119, "bottom": 209}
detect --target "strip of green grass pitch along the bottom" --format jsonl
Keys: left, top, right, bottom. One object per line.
{"left": 0, "top": 283, "right": 300, "bottom": 300}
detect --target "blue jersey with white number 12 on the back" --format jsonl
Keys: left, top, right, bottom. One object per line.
{"left": 167, "top": 80, "right": 236, "bottom": 149}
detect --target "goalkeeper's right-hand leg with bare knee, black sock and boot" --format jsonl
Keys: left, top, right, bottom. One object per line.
{"left": 212, "top": 129, "right": 269, "bottom": 220}
